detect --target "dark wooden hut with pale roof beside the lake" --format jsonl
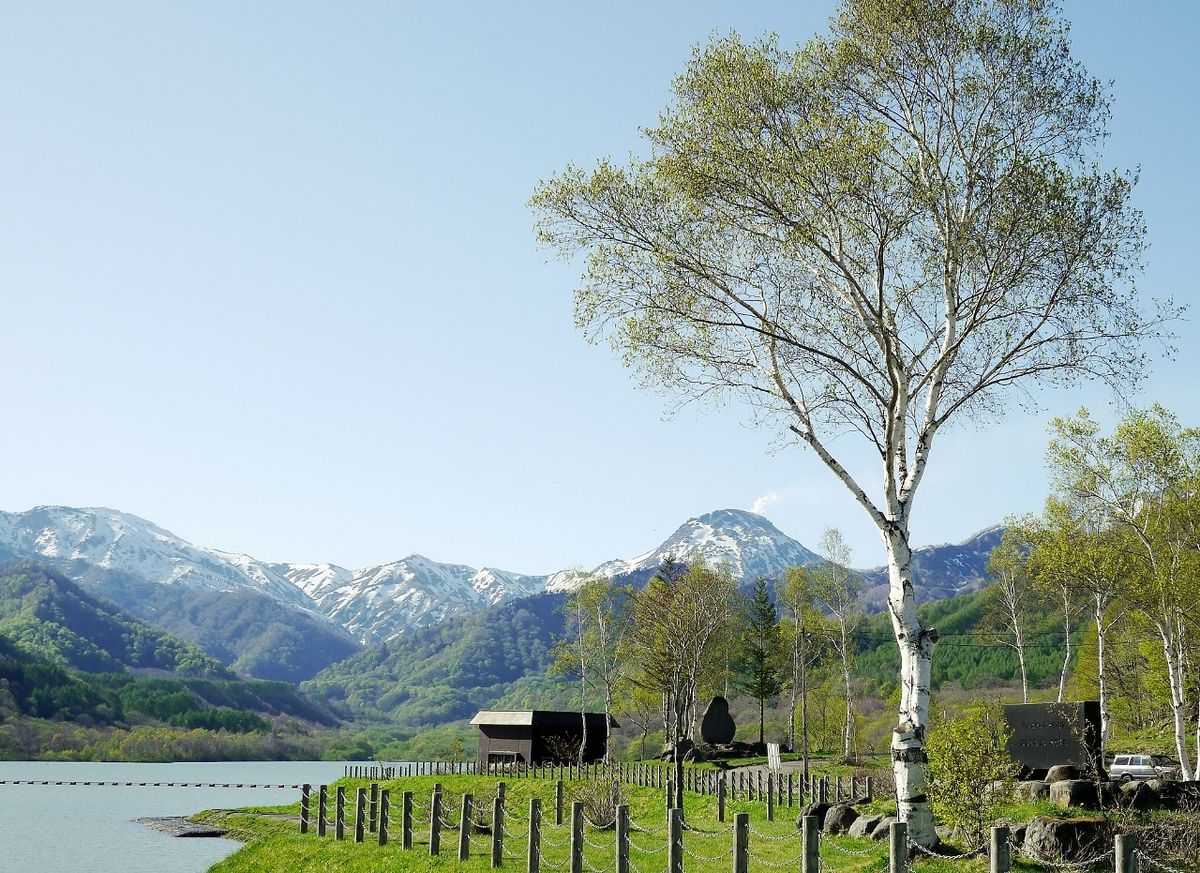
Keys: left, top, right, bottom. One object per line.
{"left": 470, "top": 710, "right": 619, "bottom": 764}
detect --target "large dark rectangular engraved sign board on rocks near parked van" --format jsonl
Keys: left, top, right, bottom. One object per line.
{"left": 1004, "top": 700, "right": 1104, "bottom": 772}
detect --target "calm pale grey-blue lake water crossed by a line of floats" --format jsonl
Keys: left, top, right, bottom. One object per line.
{"left": 0, "top": 761, "right": 344, "bottom": 873}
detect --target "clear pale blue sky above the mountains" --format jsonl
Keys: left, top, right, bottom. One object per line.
{"left": 0, "top": 0, "right": 1200, "bottom": 572}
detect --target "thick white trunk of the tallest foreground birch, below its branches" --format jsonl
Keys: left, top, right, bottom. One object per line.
{"left": 883, "top": 524, "right": 937, "bottom": 845}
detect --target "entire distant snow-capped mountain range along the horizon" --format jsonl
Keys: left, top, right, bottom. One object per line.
{"left": 0, "top": 506, "right": 1000, "bottom": 643}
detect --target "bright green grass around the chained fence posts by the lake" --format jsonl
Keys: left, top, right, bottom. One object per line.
{"left": 196, "top": 776, "right": 1056, "bottom": 873}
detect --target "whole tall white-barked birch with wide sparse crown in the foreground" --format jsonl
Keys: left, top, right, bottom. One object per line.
{"left": 532, "top": 0, "right": 1172, "bottom": 845}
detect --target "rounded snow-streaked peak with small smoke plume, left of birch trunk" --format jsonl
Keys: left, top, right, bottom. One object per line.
{"left": 595, "top": 510, "right": 821, "bottom": 583}
